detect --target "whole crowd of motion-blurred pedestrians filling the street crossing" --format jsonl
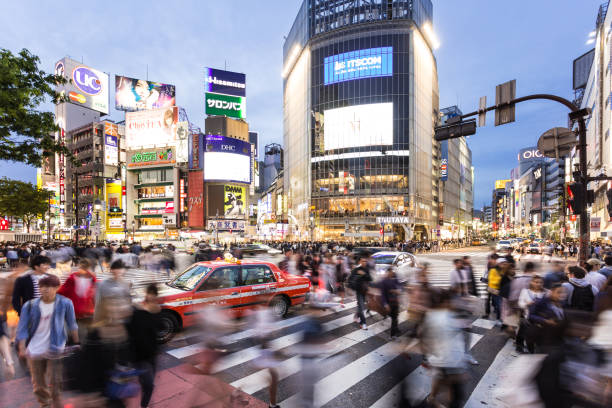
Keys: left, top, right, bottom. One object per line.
{"left": 0, "top": 242, "right": 612, "bottom": 408}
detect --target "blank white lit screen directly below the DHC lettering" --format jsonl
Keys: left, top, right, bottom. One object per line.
{"left": 204, "top": 152, "right": 251, "bottom": 183}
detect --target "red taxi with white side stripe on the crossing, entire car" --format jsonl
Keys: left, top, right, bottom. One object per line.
{"left": 159, "top": 259, "right": 310, "bottom": 342}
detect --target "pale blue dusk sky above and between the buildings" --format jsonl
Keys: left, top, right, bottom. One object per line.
{"left": 0, "top": 0, "right": 602, "bottom": 209}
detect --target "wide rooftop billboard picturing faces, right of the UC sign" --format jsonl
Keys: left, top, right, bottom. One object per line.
{"left": 115, "top": 75, "right": 176, "bottom": 112}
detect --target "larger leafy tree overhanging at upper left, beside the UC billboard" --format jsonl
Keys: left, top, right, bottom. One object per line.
{"left": 0, "top": 49, "right": 73, "bottom": 167}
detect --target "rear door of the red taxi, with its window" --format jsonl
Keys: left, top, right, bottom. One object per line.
{"left": 241, "top": 265, "right": 278, "bottom": 310}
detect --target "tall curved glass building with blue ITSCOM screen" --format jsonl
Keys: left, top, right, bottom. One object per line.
{"left": 283, "top": 0, "right": 439, "bottom": 239}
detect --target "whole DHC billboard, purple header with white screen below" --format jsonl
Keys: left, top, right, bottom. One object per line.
{"left": 204, "top": 135, "right": 251, "bottom": 183}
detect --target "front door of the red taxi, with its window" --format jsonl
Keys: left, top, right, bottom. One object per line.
{"left": 193, "top": 265, "right": 242, "bottom": 312}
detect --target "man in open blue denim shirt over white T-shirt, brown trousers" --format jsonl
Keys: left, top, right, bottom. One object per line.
{"left": 16, "top": 275, "right": 79, "bottom": 408}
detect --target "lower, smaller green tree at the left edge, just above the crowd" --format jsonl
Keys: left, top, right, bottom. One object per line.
{"left": 0, "top": 177, "right": 53, "bottom": 233}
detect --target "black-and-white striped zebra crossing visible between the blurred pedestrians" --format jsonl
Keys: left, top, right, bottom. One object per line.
{"left": 161, "top": 301, "right": 506, "bottom": 408}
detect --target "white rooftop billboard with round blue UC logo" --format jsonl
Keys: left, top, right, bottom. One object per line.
{"left": 55, "top": 58, "right": 109, "bottom": 114}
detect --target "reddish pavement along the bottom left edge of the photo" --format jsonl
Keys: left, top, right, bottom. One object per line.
{"left": 0, "top": 364, "right": 268, "bottom": 408}
